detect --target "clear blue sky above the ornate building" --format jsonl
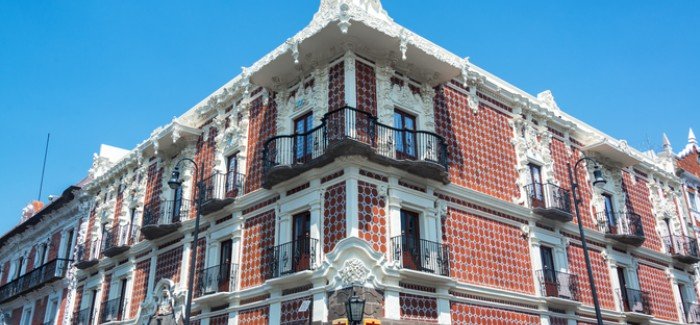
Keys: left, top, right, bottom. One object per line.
{"left": 0, "top": 0, "right": 700, "bottom": 233}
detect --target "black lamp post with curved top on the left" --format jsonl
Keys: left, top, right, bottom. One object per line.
{"left": 168, "top": 158, "right": 204, "bottom": 325}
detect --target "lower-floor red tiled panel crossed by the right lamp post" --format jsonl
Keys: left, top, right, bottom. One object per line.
{"left": 567, "top": 244, "right": 615, "bottom": 309}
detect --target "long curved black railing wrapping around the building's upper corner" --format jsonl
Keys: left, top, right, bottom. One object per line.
{"left": 263, "top": 107, "right": 448, "bottom": 171}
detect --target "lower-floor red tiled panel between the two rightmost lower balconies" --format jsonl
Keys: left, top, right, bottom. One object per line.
{"left": 637, "top": 264, "right": 678, "bottom": 320}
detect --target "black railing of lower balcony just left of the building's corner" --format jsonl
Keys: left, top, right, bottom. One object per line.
{"left": 267, "top": 238, "right": 318, "bottom": 279}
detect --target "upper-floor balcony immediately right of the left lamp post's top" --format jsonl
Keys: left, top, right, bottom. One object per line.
{"left": 201, "top": 171, "right": 244, "bottom": 215}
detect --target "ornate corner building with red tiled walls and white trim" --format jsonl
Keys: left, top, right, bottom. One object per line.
{"left": 0, "top": 0, "right": 700, "bottom": 325}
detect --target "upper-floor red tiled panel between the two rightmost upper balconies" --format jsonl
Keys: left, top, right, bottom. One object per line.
{"left": 622, "top": 171, "right": 663, "bottom": 251}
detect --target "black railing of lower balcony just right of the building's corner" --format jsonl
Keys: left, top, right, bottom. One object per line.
{"left": 391, "top": 236, "right": 450, "bottom": 276}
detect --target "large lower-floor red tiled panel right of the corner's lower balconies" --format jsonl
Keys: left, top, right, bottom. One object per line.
{"left": 442, "top": 208, "right": 535, "bottom": 293}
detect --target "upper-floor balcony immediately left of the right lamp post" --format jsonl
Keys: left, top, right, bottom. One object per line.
{"left": 525, "top": 183, "right": 574, "bottom": 222}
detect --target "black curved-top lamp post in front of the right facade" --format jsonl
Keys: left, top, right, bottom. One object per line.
{"left": 566, "top": 157, "right": 607, "bottom": 325}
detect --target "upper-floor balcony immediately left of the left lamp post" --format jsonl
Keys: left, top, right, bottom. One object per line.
{"left": 141, "top": 200, "right": 191, "bottom": 240}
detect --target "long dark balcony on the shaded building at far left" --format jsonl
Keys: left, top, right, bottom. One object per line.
{"left": 0, "top": 258, "right": 72, "bottom": 303}
